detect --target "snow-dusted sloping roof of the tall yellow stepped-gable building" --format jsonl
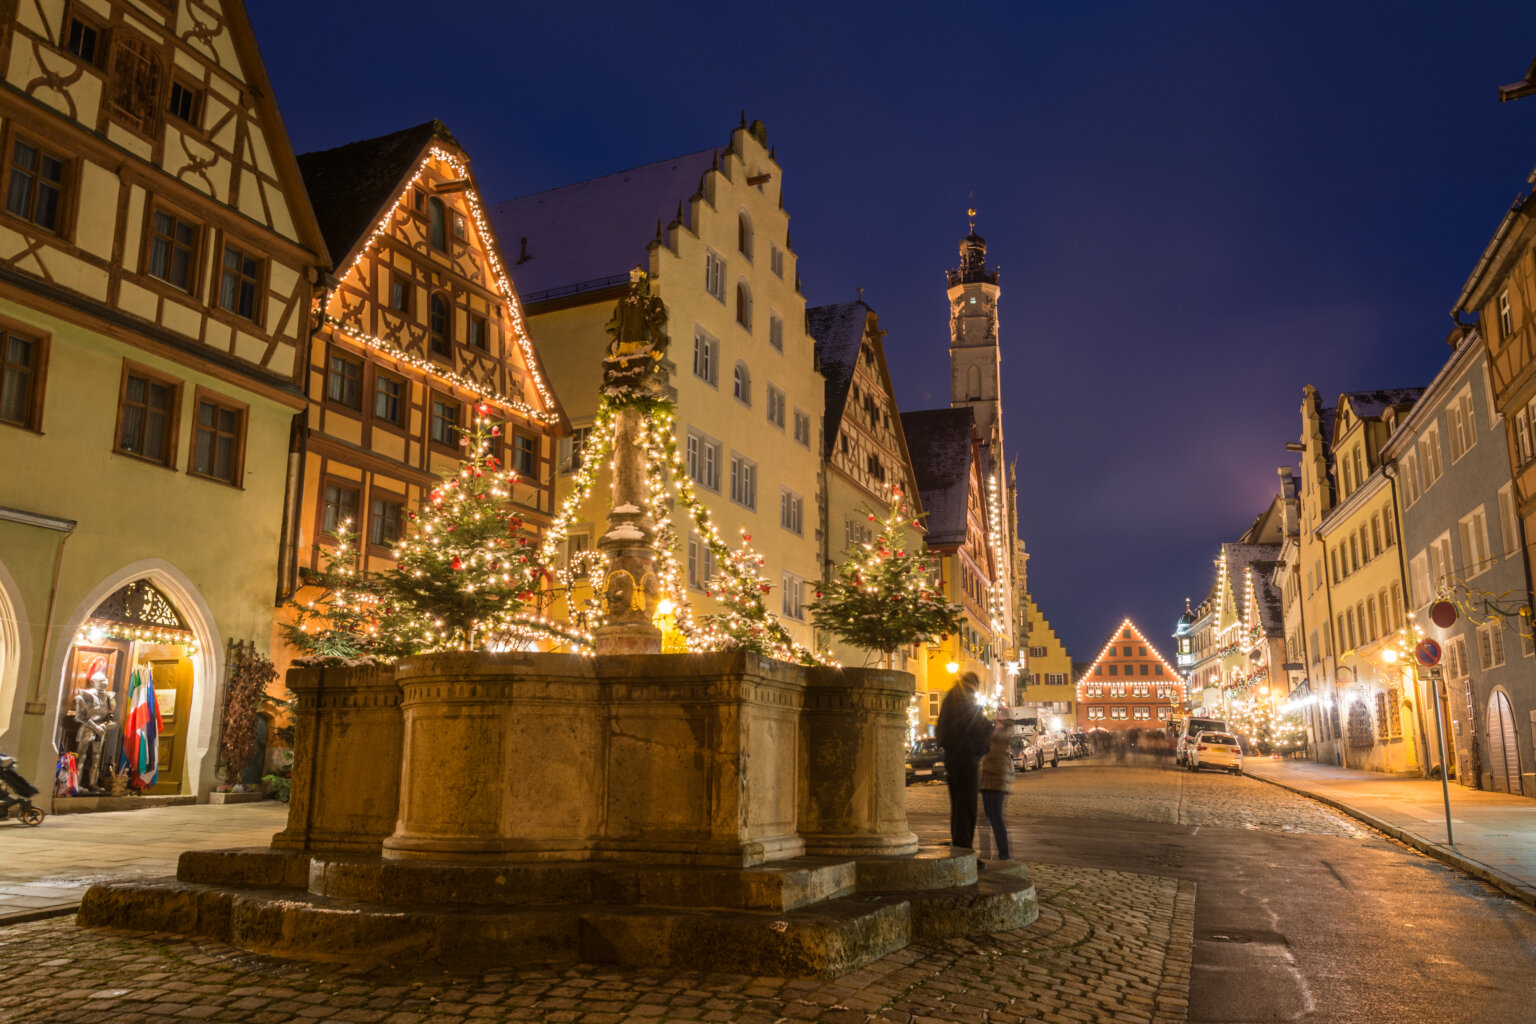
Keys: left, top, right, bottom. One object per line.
{"left": 488, "top": 149, "right": 717, "bottom": 301}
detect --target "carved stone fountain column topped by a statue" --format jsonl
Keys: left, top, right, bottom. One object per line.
{"left": 596, "top": 267, "right": 670, "bottom": 654}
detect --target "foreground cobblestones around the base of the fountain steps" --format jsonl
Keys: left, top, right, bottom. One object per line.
{"left": 0, "top": 864, "right": 1195, "bottom": 1024}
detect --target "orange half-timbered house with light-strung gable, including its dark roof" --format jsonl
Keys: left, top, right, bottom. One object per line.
{"left": 286, "top": 121, "right": 565, "bottom": 617}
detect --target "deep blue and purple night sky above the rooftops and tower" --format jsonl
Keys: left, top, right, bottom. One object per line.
{"left": 249, "top": 0, "right": 1536, "bottom": 659}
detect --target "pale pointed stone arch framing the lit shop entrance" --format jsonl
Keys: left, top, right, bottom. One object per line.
{"left": 46, "top": 559, "right": 224, "bottom": 794}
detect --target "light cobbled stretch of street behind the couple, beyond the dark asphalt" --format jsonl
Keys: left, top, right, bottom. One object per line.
{"left": 906, "top": 758, "right": 1376, "bottom": 840}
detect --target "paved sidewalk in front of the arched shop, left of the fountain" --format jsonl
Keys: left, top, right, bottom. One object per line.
{"left": 0, "top": 800, "right": 287, "bottom": 924}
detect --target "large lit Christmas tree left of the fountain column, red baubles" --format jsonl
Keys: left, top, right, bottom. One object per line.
{"left": 378, "top": 404, "right": 553, "bottom": 657}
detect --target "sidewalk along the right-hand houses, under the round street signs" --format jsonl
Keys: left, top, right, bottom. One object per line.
{"left": 1246, "top": 757, "right": 1536, "bottom": 906}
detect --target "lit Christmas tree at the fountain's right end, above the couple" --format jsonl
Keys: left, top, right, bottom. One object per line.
{"left": 811, "top": 490, "right": 960, "bottom": 663}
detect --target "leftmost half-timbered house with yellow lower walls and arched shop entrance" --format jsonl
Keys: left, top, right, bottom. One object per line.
{"left": 0, "top": 0, "right": 329, "bottom": 809}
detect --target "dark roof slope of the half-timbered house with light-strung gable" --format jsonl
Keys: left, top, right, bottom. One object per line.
{"left": 298, "top": 120, "right": 448, "bottom": 269}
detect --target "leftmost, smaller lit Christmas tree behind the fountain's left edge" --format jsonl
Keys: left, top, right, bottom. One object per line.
{"left": 283, "top": 519, "right": 378, "bottom": 659}
